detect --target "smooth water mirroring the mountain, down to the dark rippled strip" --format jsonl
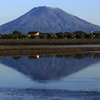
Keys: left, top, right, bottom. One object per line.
{"left": 0, "top": 52, "right": 100, "bottom": 91}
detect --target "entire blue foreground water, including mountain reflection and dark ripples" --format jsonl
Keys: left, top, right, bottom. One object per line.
{"left": 0, "top": 52, "right": 100, "bottom": 100}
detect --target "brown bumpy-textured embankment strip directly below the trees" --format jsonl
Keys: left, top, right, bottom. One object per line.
{"left": 0, "top": 39, "right": 100, "bottom": 45}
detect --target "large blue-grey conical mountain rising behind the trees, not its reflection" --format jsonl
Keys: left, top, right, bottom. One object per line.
{"left": 1, "top": 6, "right": 100, "bottom": 34}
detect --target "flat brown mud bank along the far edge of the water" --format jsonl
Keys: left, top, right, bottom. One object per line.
{"left": 0, "top": 46, "right": 100, "bottom": 56}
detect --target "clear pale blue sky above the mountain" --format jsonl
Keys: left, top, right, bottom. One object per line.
{"left": 0, "top": 0, "right": 100, "bottom": 25}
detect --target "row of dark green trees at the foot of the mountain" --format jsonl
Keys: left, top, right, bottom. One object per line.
{"left": 0, "top": 31, "right": 100, "bottom": 39}
